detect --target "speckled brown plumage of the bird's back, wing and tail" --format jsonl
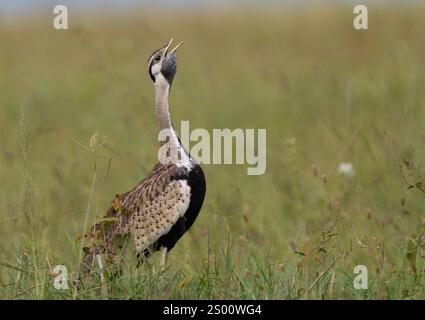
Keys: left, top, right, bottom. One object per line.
{"left": 83, "top": 163, "right": 191, "bottom": 265}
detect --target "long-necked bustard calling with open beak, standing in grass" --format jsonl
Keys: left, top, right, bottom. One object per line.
{"left": 82, "top": 39, "right": 206, "bottom": 270}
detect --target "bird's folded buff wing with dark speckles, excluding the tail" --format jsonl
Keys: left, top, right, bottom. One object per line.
{"left": 120, "top": 164, "right": 190, "bottom": 252}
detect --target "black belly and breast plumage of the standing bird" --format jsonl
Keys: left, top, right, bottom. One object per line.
{"left": 145, "top": 165, "right": 206, "bottom": 256}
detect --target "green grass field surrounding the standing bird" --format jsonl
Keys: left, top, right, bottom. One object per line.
{"left": 0, "top": 7, "right": 425, "bottom": 299}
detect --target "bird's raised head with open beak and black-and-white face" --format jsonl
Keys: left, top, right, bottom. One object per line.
{"left": 148, "top": 39, "right": 183, "bottom": 85}
